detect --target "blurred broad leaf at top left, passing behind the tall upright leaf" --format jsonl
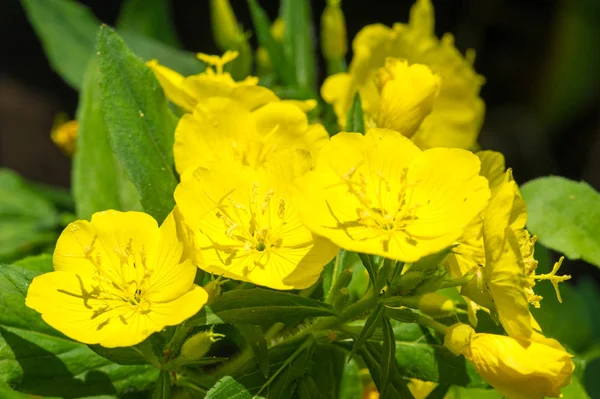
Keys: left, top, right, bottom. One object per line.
{"left": 21, "top": 0, "right": 203, "bottom": 89}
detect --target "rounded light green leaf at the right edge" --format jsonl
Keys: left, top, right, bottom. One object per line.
{"left": 521, "top": 176, "right": 600, "bottom": 267}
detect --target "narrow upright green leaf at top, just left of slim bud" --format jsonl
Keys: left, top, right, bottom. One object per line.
{"left": 281, "top": 0, "right": 316, "bottom": 91}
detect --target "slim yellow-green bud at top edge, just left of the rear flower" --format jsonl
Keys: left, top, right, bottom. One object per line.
{"left": 321, "top": 0, "right": 348, "bottom": 61}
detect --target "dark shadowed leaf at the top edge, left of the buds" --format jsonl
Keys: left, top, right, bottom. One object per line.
{"left": 117, "top": 0, "right": 179, "bottom": 47}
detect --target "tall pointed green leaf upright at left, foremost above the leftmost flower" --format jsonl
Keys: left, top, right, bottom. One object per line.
{"left": 98, "top": 26, "right": 177, "bottom": 223}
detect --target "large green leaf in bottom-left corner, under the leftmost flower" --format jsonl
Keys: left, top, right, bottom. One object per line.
{"left": 0, "top": 265, "right": 158, "bottom": 399}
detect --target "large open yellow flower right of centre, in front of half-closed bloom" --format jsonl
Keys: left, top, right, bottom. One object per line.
{"left": 300, "top": 129, "right": 489, "bottom": 262}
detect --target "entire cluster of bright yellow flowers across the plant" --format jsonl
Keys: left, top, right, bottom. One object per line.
{"left": 27, "top": 0, "right": 574, "bottom": 399}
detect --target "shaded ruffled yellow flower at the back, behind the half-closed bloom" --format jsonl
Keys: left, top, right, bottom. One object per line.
{"left": 321, "top": 0, "right": 485, "bottom": 149}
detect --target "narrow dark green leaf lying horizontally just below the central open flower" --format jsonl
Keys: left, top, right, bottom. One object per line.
{"left": 195, "top": 288, "right": 335, "bottom": 325}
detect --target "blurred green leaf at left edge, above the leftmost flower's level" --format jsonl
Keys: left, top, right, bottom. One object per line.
{"left": 0, "top": 168, "right": 60, "bottom": 262}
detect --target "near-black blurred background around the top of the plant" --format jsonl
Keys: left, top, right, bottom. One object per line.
{"left": 0, "top": 0, "right": 600, "bottom": 278}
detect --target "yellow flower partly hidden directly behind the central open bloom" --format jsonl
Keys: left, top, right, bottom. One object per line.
{"left": 173, "top": 98, "right": 329, "bottom": 174}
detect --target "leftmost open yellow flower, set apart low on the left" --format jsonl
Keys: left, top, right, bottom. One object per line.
{"left": 26, "top": 211, "right": 207, "bottom": 348}
